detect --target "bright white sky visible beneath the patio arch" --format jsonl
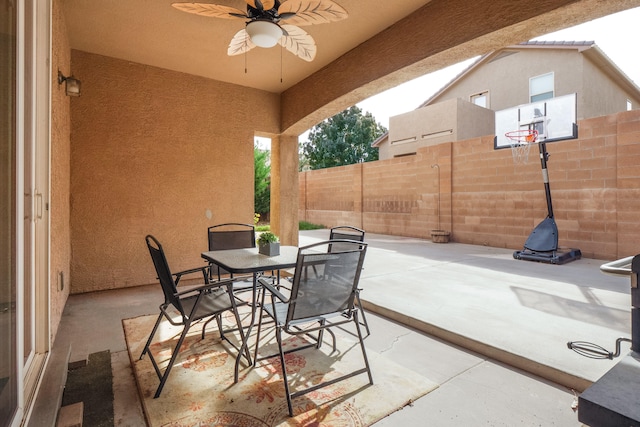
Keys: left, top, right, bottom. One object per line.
{"left": 260, "top": 7, "right": 640, "bottom": 148}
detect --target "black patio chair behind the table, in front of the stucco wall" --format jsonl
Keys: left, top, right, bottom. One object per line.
{"left": 207, "top": 222, "right": 256, "bottom": 291}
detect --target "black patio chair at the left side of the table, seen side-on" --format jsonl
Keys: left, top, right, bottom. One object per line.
{"left": 140, "top": 235, "right": 251, "bottom": 398}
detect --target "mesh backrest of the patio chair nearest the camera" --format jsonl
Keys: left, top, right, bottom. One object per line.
{"left": 287, "top": 240, "right": 367, "bottom": 324}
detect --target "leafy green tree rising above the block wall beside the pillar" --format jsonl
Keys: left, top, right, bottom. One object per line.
{"left": 300, "top": 105, "right": 387, "bottom": 169}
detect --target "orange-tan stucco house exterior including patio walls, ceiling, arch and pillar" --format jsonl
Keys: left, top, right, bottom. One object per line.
{"left": 5, "top": 0, "right": 640, "bottom": 427}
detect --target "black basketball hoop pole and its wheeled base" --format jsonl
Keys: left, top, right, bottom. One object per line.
{"left": 513, "top": 141, "right": 582, "bottom": 264}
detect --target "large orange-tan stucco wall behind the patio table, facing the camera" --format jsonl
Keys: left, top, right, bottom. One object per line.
{"left": 70, "top": 50, "right": 279, "bottom": 293}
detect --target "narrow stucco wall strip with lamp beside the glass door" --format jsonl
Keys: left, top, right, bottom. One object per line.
{"left": 48, "top": 1, "right": 73, "bottom": 342}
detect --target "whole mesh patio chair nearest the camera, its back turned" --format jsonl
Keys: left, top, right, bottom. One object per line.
{"left": 254, "top": 240, "right": 373, "bottom": 416}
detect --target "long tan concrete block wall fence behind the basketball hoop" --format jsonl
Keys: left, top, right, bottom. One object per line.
{"left": 299, "top": 110, "right": 640, "bottom": 260}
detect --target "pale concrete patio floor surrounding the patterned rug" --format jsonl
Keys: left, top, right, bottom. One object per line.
{"left": 55, "top": 230, "right": 630, "bottom": 426}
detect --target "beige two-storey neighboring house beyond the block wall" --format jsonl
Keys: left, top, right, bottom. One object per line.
{"left": 373, "top": 41, "right": 640, "bottom": 160}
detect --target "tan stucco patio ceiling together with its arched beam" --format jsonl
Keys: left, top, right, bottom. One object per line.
{"left": 60, "top": 0, "right": 640, "bottom": 135}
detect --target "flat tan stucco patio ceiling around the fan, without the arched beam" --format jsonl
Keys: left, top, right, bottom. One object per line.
{"left": 63, "top": 0, "right": 429, "bottom": 93}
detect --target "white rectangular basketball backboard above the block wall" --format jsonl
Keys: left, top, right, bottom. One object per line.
{"left": 493, "top": 93, "right": 578, "bottom": 150}
